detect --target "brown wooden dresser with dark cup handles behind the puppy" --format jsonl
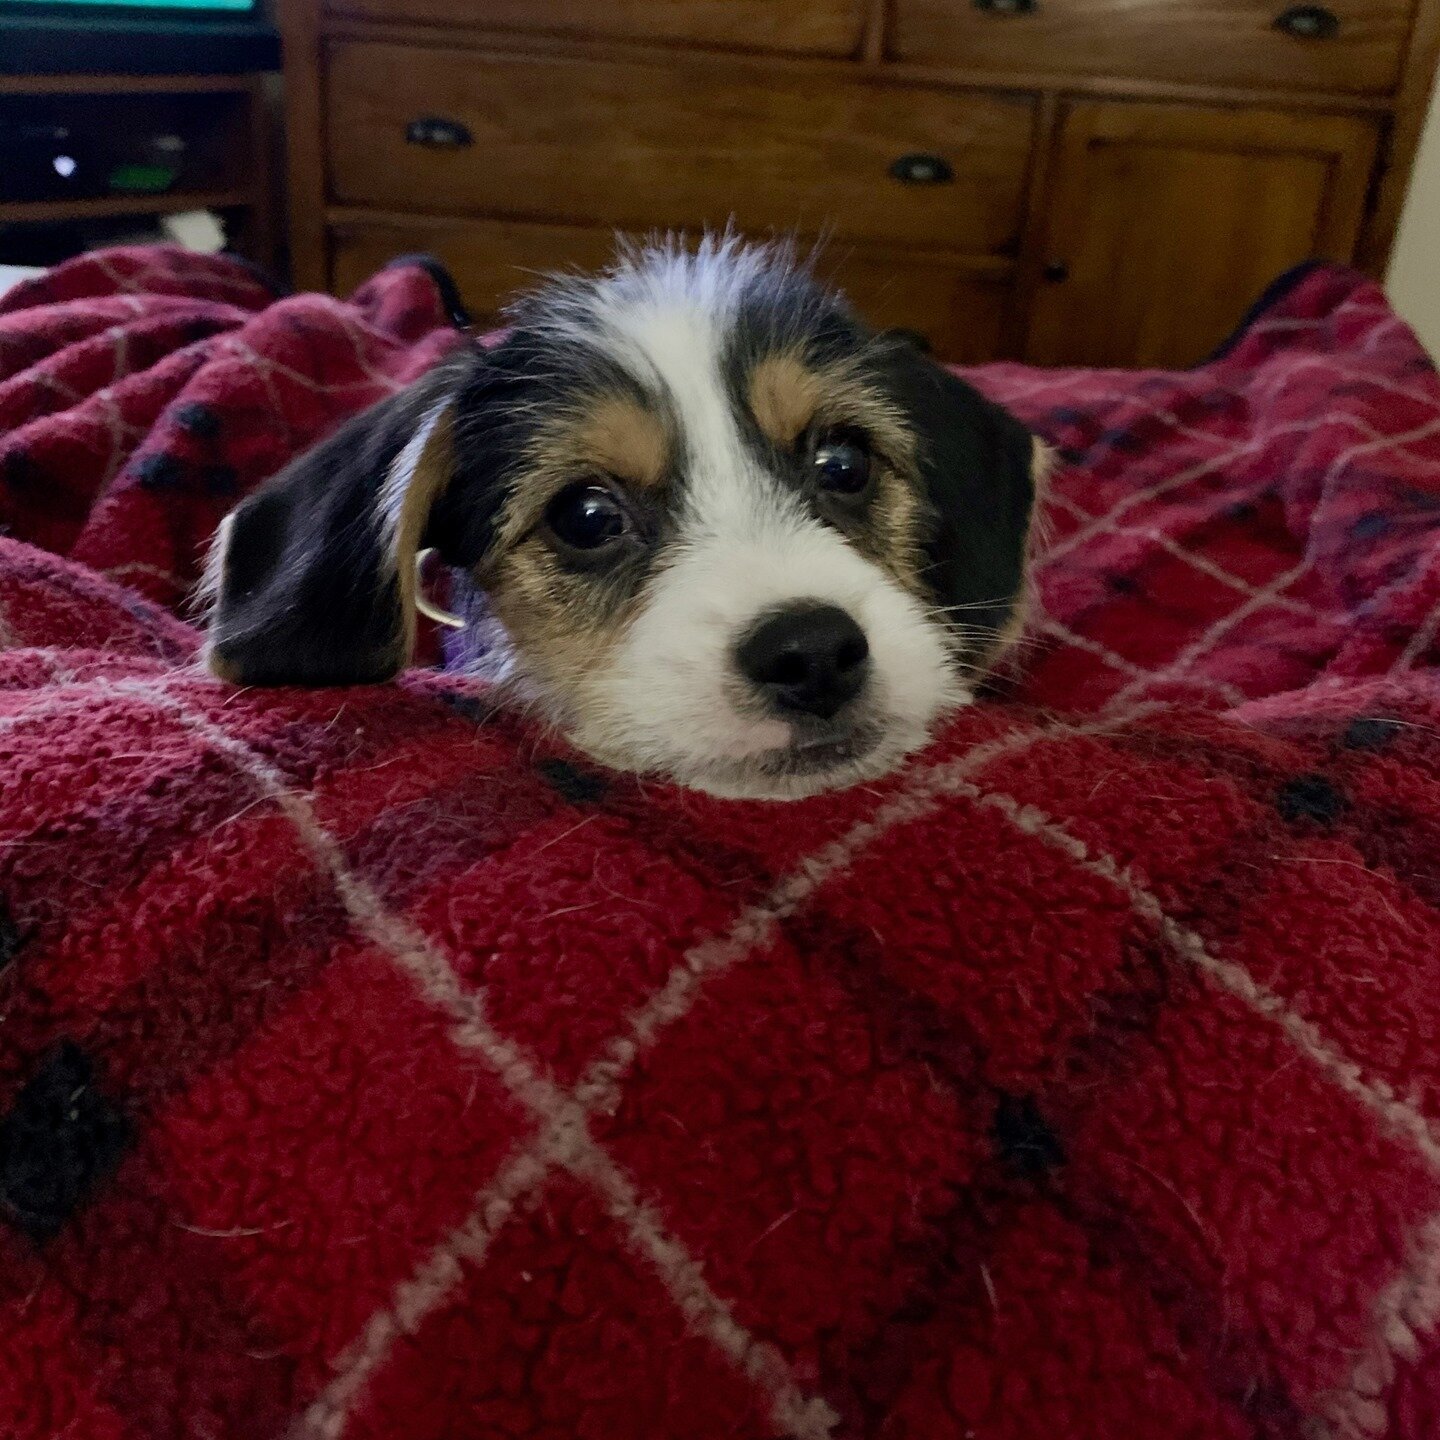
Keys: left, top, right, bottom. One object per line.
{"left": 279, "top": 0, "right": 1440, "bottom": 366}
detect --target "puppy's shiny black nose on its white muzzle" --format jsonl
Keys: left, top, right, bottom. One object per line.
{"left": 736, "top": 605, "right": 870, "bottom": 720}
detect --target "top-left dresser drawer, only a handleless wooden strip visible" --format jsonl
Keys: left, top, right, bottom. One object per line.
{"left": 330, "top": 0, "right": 864, "bottom": 55}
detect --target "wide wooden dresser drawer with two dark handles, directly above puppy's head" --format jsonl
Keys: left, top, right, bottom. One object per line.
{"left": 327, "top": 42, "right": 1034, "bottom": 253}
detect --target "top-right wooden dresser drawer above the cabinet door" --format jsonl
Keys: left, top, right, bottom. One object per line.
{"left": 891, "top": 0, "right": 1414, "bottom": 92}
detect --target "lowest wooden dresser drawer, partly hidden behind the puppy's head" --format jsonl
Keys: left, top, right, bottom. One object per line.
{"left": 330, "top": 220, "right": 1009, "bottom": 364}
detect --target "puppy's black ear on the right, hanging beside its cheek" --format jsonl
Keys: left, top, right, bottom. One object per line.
{"left": 886, "top": 344, "right": 1048, "bottom": 636}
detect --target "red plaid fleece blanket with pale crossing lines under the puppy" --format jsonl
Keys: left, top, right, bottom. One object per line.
{"left": 0, "top": 251, "right": 1440, "bottom": 1440}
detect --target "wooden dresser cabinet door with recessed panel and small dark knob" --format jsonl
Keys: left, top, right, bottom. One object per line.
{"left": 1025, "top": 102, "right": 1378, "bottom": 367}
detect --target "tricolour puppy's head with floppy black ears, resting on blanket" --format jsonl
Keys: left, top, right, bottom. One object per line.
{"left": 209, "top": 239, "right": 1038, "bottom": 798}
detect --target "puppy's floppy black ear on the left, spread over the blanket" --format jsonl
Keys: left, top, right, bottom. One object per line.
{"left": 204, "top": 360, "right": 467, "bottom": 685}
